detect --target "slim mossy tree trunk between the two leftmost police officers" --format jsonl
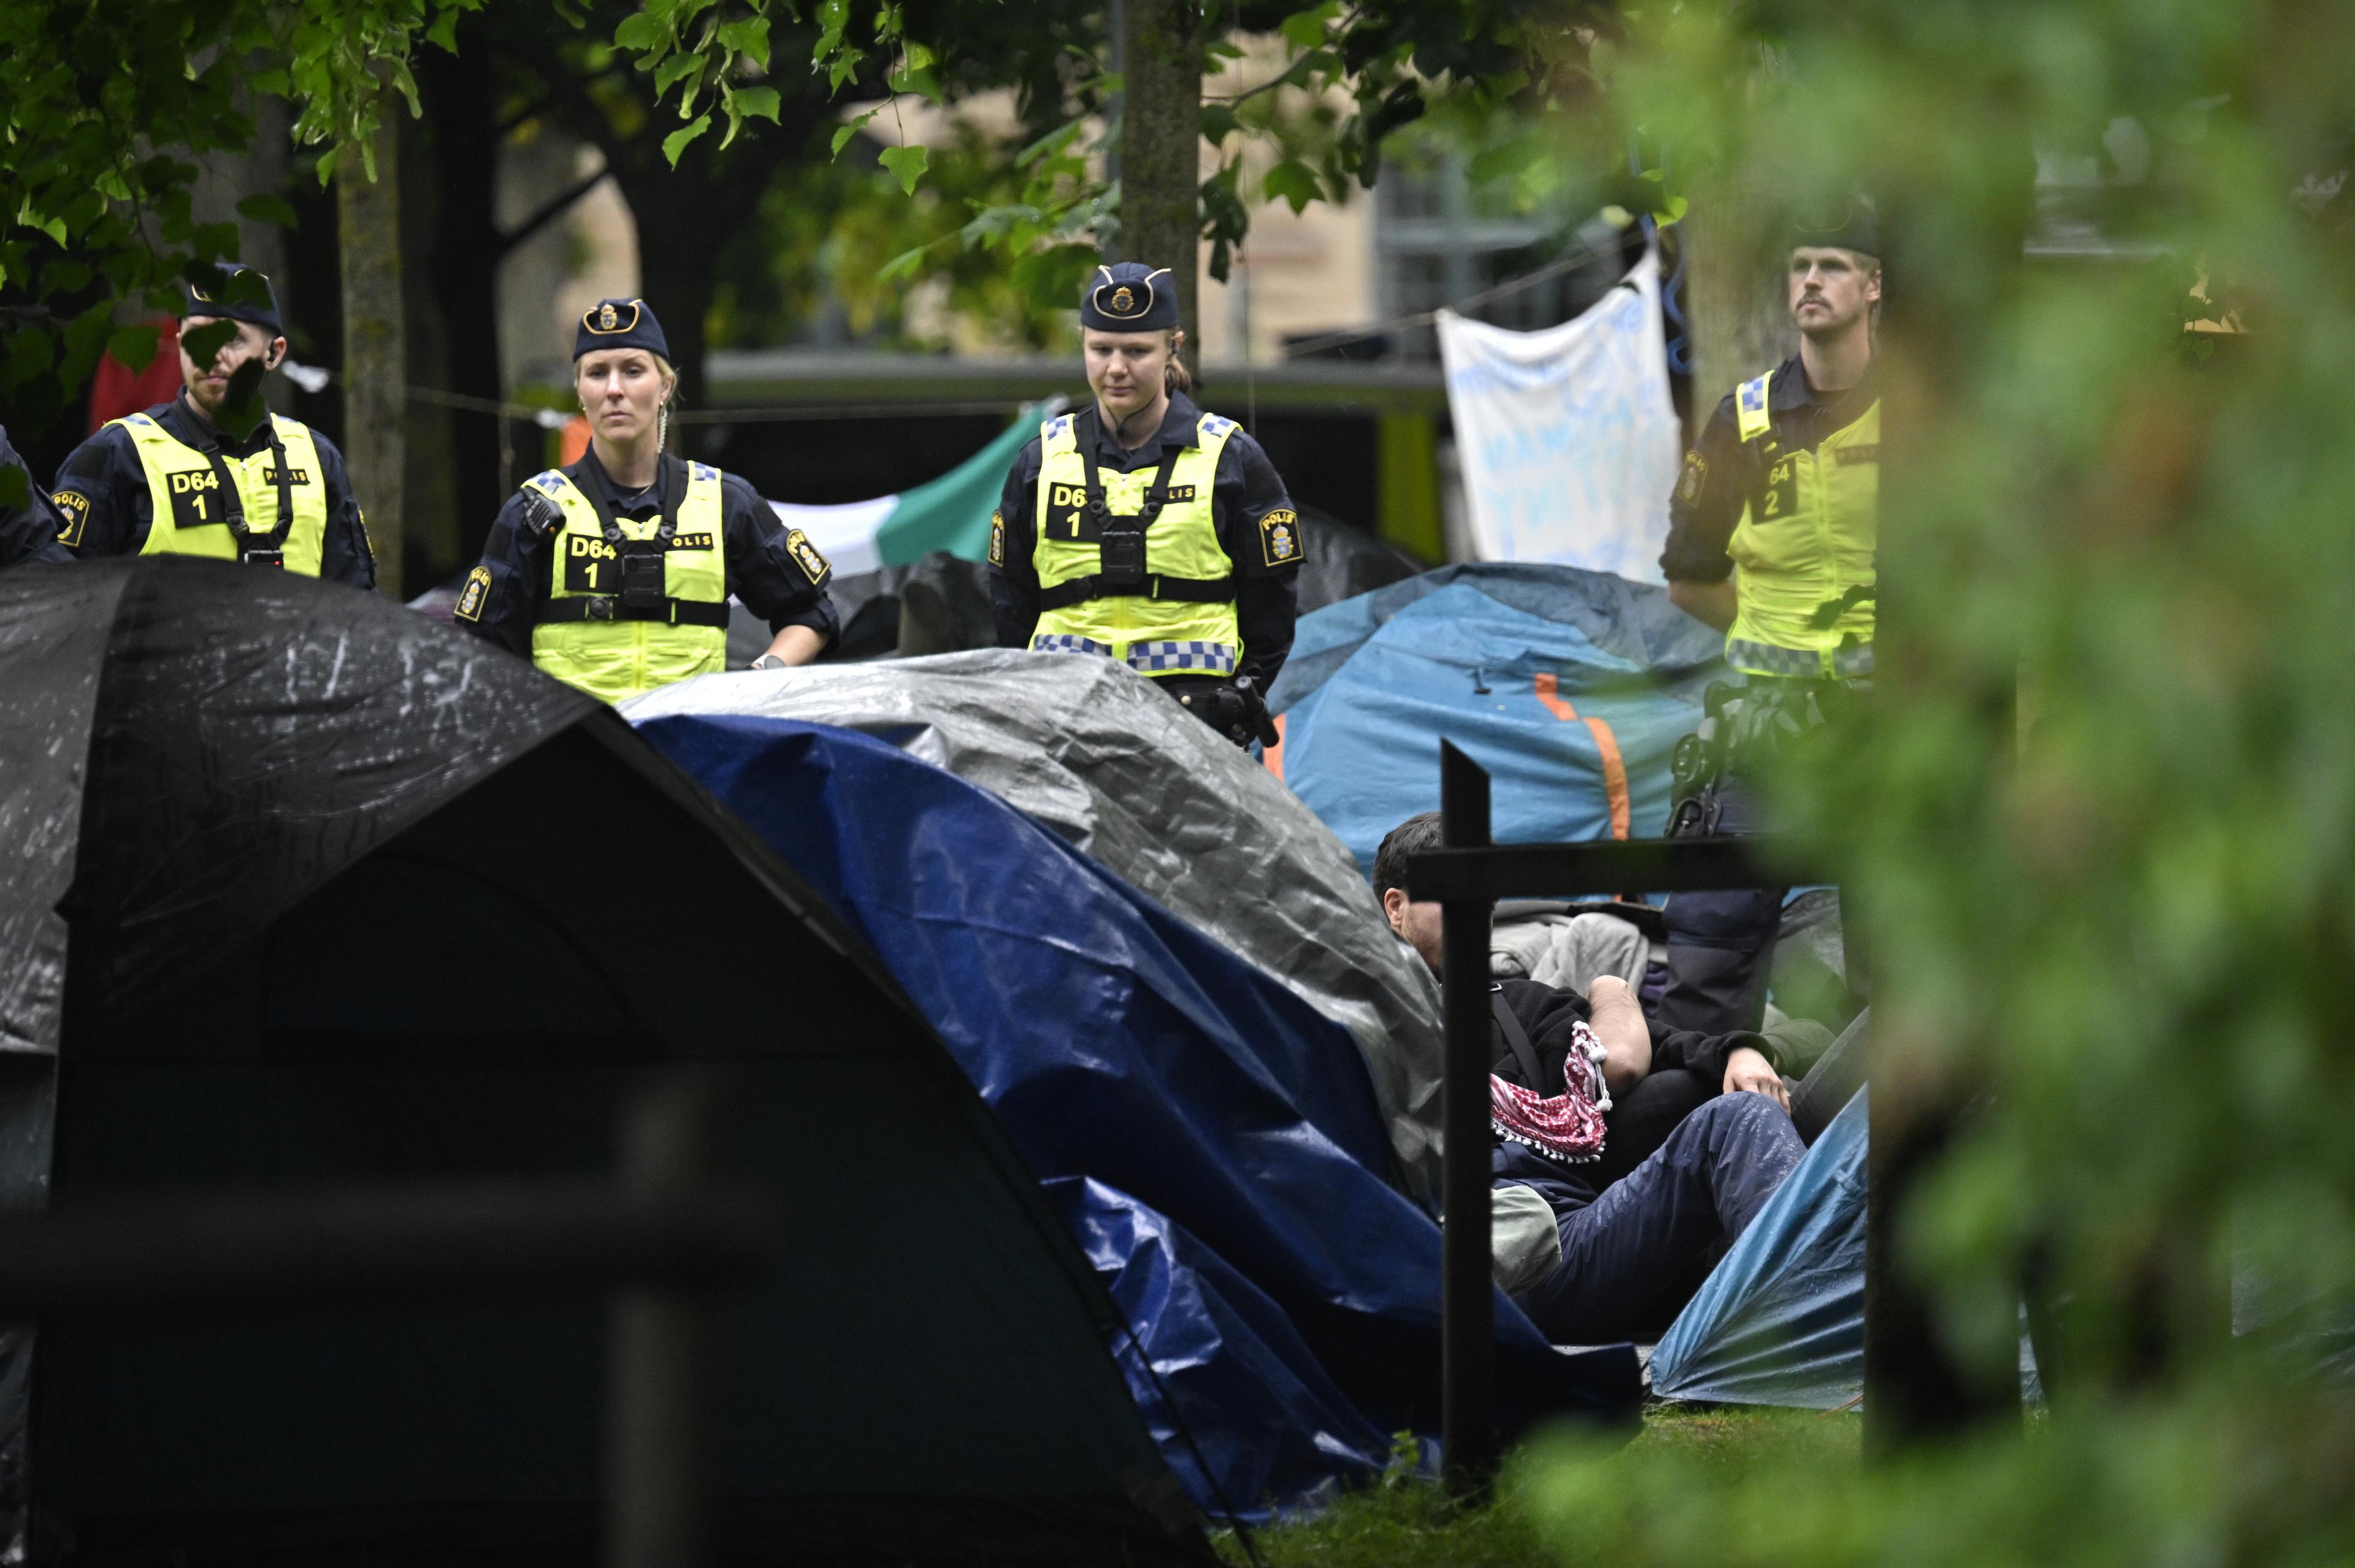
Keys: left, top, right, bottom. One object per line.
{"left": 334, "top": 92, "right": 410, "bottom": 600}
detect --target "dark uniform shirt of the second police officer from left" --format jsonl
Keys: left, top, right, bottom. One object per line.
{"left": 457, "top": 447, "right": 838, "bottom": 659}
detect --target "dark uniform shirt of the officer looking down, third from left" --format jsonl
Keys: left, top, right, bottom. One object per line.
{"left": 989, "top": 391, "right": 1300, "bottom": 692}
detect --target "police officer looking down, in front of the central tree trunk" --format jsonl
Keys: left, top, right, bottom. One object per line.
{"left": 989, "top": 261, "right": 1303, "bottom": 744}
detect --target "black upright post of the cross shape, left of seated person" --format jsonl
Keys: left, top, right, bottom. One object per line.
{"left": 1439, "top": 741, "right": 1498, "bottom": 1495}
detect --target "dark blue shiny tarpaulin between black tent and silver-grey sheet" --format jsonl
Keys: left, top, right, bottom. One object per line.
{"left": 640, "top": 716, "right": 1637, "bottom": 1514}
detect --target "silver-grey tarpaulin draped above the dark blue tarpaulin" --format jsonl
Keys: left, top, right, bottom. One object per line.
{"left": 622, "top": 650, "right": 1441, "bottom": 1201}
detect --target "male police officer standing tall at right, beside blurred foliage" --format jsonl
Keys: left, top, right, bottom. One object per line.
{"left": 1656, "top": 196, "right": 1882, "bottom": 1033}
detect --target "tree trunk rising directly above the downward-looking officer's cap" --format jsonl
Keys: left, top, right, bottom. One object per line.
{"left": 1121, "top": 0, "right": 1201, "bottom": 358}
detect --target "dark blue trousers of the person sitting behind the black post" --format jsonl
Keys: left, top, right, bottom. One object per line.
{"left": 1519, "top": 1095, "right": 1806, "bottom": 1344}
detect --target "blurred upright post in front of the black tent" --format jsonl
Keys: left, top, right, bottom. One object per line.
{"left": 605, "top": 1071, "right": 716, "bottom": 1568}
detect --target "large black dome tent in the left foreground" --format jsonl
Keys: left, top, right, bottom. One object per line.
{"left": 0, "top": 558, "right": 1203, "bottom": 1561}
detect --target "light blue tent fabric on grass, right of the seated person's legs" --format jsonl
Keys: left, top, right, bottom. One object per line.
{"left": 1651, "top": 1090, "right": 1867, "bottom": 1410}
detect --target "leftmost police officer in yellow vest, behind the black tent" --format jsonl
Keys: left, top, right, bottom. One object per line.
{"left": 50, "top": 269, "right": 377, "bottom": 589}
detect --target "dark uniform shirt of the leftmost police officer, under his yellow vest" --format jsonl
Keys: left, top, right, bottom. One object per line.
{"left": 52, "top": 393, "right": 377, "bottom": 589}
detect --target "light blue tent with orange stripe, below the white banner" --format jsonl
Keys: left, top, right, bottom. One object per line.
{"left": 1272, "top": 563, "right": 1724, "bottom": 869}
